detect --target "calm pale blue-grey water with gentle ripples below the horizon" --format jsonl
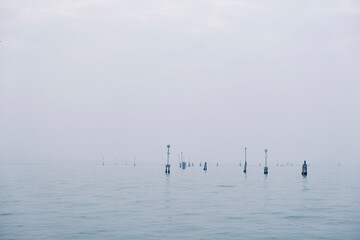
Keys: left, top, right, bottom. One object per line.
{"left": 0, "top": 164, "right": 360, "bottom": 240}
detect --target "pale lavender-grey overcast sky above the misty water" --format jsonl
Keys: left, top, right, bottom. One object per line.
{"left": 0, "top": 0, "right": 360, "bottom": 164}
